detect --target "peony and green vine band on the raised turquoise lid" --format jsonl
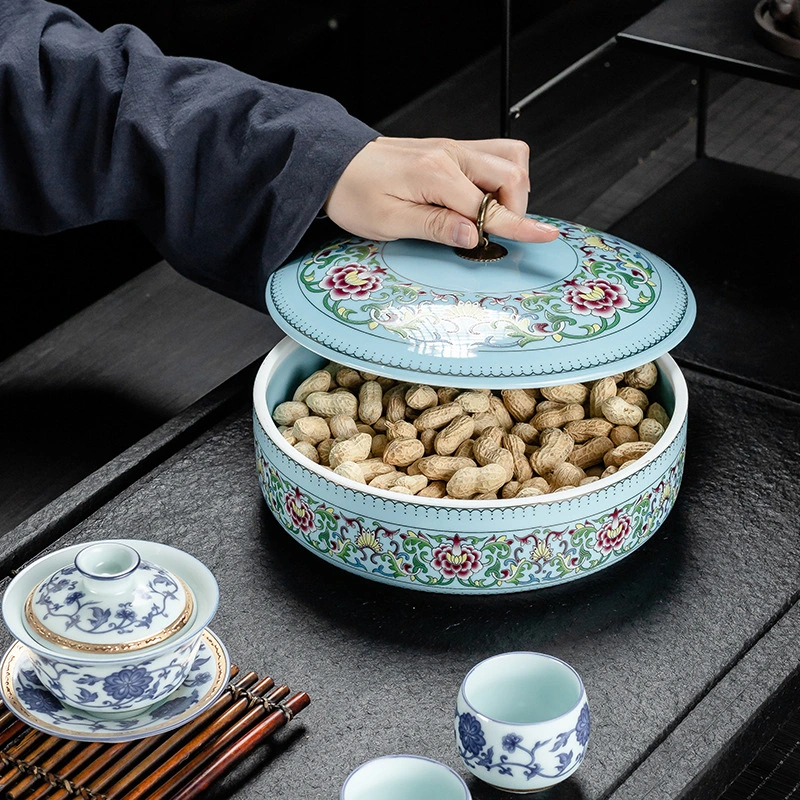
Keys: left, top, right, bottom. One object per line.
{"left": 300, "top": 225, "right": 658, "bottom": 348}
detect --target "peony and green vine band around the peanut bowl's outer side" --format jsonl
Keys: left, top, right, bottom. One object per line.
{"left": 257, "top": 440, "right": 684, "bottom": 590}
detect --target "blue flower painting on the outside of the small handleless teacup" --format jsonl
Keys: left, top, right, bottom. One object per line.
{"left": 456, "top": 703, "right": 590, "bottom": 780}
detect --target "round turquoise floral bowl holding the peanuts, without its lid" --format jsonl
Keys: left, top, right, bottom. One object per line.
{"left": 254, "top": 338, "right": 688, "bottom": 594}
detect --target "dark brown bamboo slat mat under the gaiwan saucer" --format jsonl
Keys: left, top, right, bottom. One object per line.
{"left": 0, "top": 667, "right": 310, "bottom": 800}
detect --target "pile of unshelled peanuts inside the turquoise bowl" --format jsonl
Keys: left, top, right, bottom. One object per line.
{"left": 272, "top": 362, "right": 669, "bottom": 500}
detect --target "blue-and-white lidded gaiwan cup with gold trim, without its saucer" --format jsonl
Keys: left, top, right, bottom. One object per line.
{"left": 3, "top": 540, "right": 219, "bottom": 719}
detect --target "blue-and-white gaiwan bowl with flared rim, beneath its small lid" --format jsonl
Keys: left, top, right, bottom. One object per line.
{"left": 2, "top": 539, "right": 219, "bottom": 719}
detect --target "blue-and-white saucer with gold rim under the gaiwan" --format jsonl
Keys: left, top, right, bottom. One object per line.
{"left": 0, "top": 628, "right": 231, "bottom": 743}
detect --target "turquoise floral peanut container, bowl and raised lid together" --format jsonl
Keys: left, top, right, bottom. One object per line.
{"left": 254, "top": 218, "right": 695, "bottom": 594}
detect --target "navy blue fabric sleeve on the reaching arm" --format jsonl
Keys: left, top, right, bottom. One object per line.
{"left": 0, "top": 0, "right": 378, "bottom": 309}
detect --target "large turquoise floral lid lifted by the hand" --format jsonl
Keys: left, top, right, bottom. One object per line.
{"left": 266, "top": 217, "right": 695, "bottom": 388}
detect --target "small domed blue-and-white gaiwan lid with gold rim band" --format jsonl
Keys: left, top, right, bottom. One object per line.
{"left": 25, "top": 541, "right": 194, "bottom": 654}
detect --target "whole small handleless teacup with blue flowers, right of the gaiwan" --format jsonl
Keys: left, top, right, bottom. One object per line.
{"left": 455, "top": 652, "right": 589, "bottom": 793}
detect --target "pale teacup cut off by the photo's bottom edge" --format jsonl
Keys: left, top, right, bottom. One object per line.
{"left": 341, "top": 755, "right": 472, "bottom": 800}
